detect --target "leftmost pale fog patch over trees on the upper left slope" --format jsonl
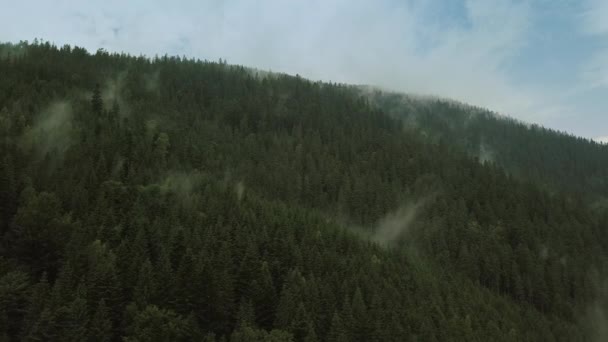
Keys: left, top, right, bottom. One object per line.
{"left": 21, "top": 101, "right": 73, "bottom": 157}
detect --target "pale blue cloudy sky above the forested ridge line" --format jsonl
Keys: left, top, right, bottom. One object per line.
{"left": 0, "top": 0, "right": 608, "bottom": 142}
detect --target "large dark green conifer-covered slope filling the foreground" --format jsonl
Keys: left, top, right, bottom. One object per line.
{"left": 0, "top": 42, "right": 608, "bottom": 341}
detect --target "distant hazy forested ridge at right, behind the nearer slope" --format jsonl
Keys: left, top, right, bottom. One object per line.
{"left": 362, "top": 88, "right": 608, "bottom": 202}
